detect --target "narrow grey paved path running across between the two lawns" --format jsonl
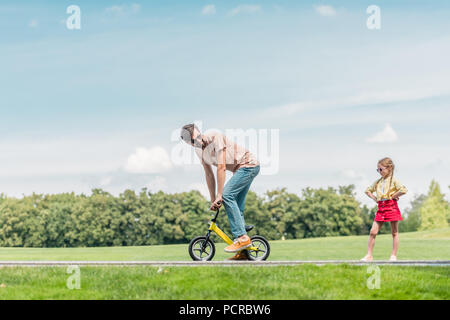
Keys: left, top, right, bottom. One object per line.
{"left": 0, "top": 260, "right": 450, "bottom": 267}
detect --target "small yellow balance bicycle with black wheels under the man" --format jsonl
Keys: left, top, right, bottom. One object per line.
{"left": 189, "top": 209, "right": 270, "bottom": 261}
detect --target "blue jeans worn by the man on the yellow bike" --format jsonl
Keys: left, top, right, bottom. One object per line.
{"left": 222, "top": 166, "right": 259, "bottom": 239}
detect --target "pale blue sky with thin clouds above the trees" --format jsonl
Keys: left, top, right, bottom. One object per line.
{"left": 0, "top": 1, "right": 450, "bottom": 210}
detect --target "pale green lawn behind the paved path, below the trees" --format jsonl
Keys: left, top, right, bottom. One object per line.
{"left": 0, "top": 228, "right": 450, "bottom": 261}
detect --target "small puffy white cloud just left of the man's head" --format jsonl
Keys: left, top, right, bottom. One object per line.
{"left": 124, "top": 146, "right": 172, "bottom": 173}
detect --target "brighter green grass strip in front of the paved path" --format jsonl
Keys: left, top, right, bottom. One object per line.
{"left": 0, "top": 265, "right": 450, "bottom": 300}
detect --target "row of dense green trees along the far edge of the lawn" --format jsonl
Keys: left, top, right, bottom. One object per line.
{"left": 0, "top": 180, "right": 450, "bottom": 247}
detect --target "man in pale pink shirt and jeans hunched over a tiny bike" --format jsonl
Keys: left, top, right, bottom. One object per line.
{"left": 181, "top": 124, "right": 260, "bottom": 260}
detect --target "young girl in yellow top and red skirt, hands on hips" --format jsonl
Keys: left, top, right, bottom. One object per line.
{"left": 361, "top": 158, "right": 408, "bottom": 261}
